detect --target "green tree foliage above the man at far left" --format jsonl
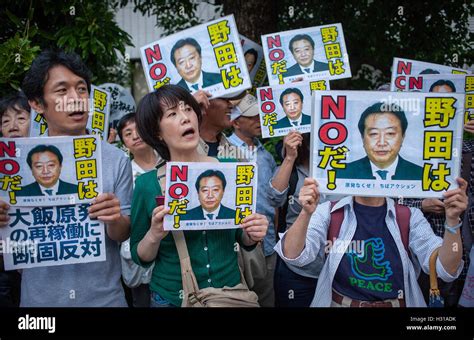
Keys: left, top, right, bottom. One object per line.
{"left": 0, "top": 0, "right": 132, "bottom": 95}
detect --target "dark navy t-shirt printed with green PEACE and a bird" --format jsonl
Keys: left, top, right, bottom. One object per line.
{"left": 333, "top": 201, "right": 403, "bottom": 301}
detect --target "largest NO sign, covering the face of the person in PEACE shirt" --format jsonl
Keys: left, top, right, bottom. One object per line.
{"left": 310, "top": 91, "right": 464, "bottom": 198}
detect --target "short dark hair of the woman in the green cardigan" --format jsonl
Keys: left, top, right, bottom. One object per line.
{"left": 135, "top": 85, "right": 202, "bottom": 161}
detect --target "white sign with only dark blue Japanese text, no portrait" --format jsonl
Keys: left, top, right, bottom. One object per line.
{"left": 0, "top": 204, "right": 106, "bottom": 270}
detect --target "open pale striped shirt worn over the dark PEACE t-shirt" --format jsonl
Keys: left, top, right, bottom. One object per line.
{"left": 275, "top": 196, "right": 464, "bottom": 307}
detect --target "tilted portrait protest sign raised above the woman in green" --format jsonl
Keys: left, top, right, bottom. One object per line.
{"left": 140, "top": 15, "right": 252, "bottom": 98}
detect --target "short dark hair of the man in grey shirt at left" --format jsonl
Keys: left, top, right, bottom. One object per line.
{"left": 22, "top": 50, "right": 91, "bottom": 104}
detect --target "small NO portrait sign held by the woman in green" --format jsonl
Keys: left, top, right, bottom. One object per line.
{"left": 164, "top": 162, "right": 257, "bottom": 230}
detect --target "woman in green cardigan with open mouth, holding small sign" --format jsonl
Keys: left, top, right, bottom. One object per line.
{"left": 130, "top": 85, "right": 268, "bottom": 307}
